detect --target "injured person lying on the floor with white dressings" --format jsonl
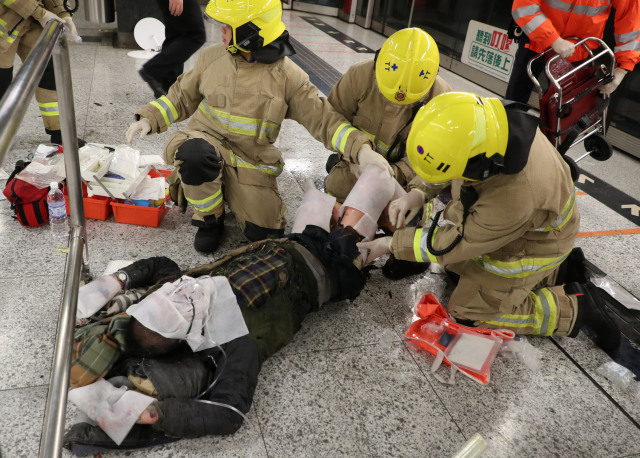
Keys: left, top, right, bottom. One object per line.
{"left": 64, "top": 166, "right": 404, "bottom": 454}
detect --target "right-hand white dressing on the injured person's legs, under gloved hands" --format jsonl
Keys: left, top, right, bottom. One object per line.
{"left": 340, "top": 165, "right": 397, "bottom": 240}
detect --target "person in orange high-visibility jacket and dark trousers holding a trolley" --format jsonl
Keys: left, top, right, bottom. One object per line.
{"left": 505, "top": 0, "right": 640, "bottom": 103}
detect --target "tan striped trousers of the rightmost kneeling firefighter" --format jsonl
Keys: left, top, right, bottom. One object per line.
{"left": 447, "top": 261, "right": 578, "bottom": 336}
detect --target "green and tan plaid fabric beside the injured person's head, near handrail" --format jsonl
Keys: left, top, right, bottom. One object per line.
{"left": 69, "top": 313, "right": 131, "bottom": 388}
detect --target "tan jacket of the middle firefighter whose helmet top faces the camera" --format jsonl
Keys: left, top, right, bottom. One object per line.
{"left": 329, "top": 59, "right": 451, "bottom": 162}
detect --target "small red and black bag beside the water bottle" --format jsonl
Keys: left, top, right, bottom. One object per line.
{"left": 2, "top": 161, "right": 49, "bottom": 227}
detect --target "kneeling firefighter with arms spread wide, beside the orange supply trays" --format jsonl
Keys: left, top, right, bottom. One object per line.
{"left": 127, "top": 0, "right": 382, "bottom": 253}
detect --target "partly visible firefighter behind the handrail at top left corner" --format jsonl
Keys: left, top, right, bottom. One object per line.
{"left": 0, "top": 0, "right": 85, "bottom": 146}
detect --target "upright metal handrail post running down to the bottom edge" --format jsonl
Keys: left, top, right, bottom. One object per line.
{"left": 39, "top": 29, "right": 89, "bottom": 457}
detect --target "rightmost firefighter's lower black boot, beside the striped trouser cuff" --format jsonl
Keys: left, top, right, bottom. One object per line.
{"left": 564, "top": 283, "right": 620, "bottom": 350}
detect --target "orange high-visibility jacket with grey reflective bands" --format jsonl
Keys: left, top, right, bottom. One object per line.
{"left": 511, "top": 0, "right": 640, "bottom": 71}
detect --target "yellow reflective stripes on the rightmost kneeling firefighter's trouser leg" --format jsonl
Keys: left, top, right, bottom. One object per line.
{"left": 483, "top": 288, "right": 558, "bottom": 336}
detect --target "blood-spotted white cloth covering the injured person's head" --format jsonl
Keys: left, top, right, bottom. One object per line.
{"left": 127, "top": 276, "right": 249, "bottom": 351}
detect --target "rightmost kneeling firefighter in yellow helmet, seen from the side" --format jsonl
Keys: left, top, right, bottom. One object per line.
{"left": 361, "top": 92, "right": 620, "bottom": 349}
